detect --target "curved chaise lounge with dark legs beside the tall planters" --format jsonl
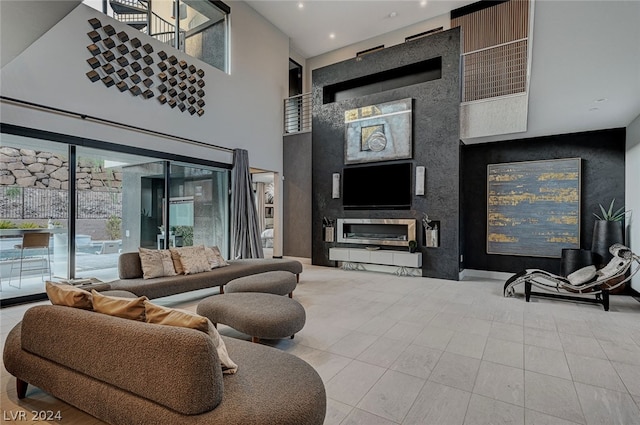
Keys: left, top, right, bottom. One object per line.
{"left": 504, "top": 244, "right": 640, "bottom": 311}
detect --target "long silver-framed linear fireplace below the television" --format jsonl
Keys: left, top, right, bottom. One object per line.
{"left": 336, "top": 218, "right": 416, "bottom": 246}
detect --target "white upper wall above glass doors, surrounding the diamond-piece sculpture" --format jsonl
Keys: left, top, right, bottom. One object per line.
{"left": 0, "top": 2, "right": 289, "bottom": 171}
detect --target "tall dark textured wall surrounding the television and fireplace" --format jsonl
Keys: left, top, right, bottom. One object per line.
{"left": 312, "top": 28, "right": 460, "bottom": 280}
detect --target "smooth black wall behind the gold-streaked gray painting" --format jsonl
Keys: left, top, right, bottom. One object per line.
{"left": 462, "top": 128, "right": 625, "bottom": 273}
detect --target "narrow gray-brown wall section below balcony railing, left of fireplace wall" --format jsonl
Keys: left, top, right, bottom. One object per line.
{"left": 282, "top": 133, "right": 311, "bottom": 258}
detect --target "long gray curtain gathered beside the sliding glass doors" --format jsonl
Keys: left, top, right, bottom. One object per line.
{"left": 231, "top": 149, "right": 264, "bottom": 258}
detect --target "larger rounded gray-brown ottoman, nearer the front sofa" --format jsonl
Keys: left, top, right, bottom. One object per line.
{"left": 197, "top": 292, "right": 306, "bottom": 342}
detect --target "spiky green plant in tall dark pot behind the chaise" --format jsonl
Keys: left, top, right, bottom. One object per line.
{"left": 591, "top": 198, "right": 629, "bottom": 267}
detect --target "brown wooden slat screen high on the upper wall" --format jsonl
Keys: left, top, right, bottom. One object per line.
{"left": 451, "top": 0, "right": 529, "bottom": 102}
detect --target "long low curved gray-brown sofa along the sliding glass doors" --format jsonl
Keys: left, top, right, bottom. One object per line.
{"left": 110, "top": 252, "right": 302, "bottom": 299}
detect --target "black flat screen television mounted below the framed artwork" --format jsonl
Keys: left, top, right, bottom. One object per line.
{"left": 342, "top": 162, "right": 411, "bottom": 210}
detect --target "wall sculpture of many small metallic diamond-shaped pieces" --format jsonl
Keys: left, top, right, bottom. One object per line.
{"left": 86, "top": 18, "right": 205, "bottom": 117}
